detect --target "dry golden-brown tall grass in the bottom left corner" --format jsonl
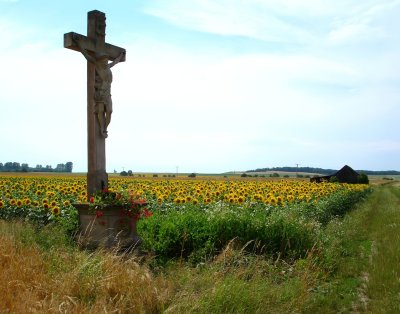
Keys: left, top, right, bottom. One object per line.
{"left": 0, "top": 222, "right": 172, "bottom": 313}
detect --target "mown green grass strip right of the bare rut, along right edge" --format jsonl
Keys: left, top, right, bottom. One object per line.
{"left": 365, "top": 186, "right": 400, "bottom": 313}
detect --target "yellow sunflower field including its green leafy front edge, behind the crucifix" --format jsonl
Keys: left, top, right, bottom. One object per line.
{"left": 0, "top": 175, "right": 370, "bottom": 262}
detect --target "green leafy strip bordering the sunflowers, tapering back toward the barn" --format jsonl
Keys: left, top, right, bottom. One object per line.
{"left": 138, "top": 186, "right": 369, "bottom": 262}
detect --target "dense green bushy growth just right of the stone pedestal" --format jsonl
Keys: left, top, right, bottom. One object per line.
{"left": 138, "top": 206, "right": 319, "bottom": 262}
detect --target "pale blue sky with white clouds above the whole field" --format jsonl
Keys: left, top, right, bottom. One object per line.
{"left": 0, "top": 0, "right": 400, "bottom": 172}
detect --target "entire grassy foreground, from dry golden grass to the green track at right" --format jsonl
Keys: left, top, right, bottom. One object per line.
{"left": 0, "top": 185, "right": 400, "bottom": 313}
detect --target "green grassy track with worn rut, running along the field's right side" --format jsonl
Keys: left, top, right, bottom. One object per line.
{"left": 304, "top": 184, "right": 400, "bottom": 313}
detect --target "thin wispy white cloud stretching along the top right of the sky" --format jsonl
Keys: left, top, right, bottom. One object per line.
{"left": 144, "top": 0, "right": 400, "bottom": 49}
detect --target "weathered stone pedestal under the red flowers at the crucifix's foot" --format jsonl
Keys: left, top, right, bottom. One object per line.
{"left": 74, "top": 203, "right": 146, "bottom": 250}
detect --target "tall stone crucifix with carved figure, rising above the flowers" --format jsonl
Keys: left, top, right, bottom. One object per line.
{"left": 64, "top": 10, "right": 126, "bottom": 199}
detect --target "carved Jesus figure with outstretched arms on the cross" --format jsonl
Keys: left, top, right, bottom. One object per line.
{"left": 74, "top": 37, "right": 125, "bottom": 138}
